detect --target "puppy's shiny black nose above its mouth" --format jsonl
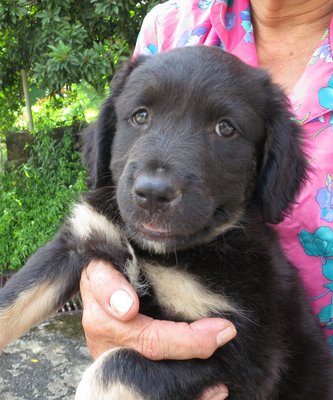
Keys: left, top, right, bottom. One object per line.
{"left": 134, "top": 175, "right": 180, "bottom": 213}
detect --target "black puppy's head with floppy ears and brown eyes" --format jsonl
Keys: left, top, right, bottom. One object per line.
{"left": 86, "top": 47, "right": 305, "bottom": 252}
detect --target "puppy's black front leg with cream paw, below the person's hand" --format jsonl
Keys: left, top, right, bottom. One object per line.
{"left": 75, "top": 348, "right": 210, "bottom": 400}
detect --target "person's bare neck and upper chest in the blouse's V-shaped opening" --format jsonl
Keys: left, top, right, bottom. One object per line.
{"left": 251, "top": 0, "right": 333, "bottom": 93}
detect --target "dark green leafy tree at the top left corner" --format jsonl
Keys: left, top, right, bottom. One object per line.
{"left": 0, "top": 0, "right": 157, "bottom": 127}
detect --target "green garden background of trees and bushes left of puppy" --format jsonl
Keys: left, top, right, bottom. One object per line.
{"left": 0, "top": 0, "right": 156, "bottom": 274}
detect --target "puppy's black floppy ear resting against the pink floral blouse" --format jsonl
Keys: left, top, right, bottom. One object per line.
{"left": 258, "top": 79, "right": 306, "bottom": 224}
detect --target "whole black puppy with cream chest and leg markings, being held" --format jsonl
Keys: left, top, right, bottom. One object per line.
{"left": 0, "top": 47, "right": 333, "bottom": 400}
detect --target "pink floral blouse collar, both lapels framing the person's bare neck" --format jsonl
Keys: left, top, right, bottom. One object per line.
{"left": 211, "top": 0, "right": 333, "bottom": 123}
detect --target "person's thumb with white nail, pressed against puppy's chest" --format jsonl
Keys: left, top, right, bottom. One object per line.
{"left": 81, "top": 260, "right": 139, "bottom": 321}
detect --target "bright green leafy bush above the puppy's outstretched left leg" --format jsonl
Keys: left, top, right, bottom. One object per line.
{"left": 0, "top": 128, "right": 86, "bottom": 273}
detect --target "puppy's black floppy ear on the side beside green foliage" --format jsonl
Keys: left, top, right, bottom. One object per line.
{"left": 82, "top": 56, "right": 146, "bottom": 189}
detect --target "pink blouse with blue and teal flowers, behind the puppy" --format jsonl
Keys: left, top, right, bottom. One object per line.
{"left": 135, "top": 0, "right": 333, "bottom": 348}
